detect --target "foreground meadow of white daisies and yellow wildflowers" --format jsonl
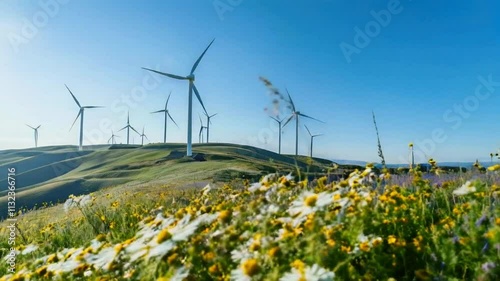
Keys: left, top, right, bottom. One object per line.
{"left": 0, "top": 164, "right": 500, "bottom": 281}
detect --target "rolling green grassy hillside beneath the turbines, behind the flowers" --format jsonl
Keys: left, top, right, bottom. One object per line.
{"left": 0, "top": 144, "right": 348, "bottom": 217}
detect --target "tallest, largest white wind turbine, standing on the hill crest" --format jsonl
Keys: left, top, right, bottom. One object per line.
{"left": 143, "top": 39, "right": 215, "bottom": 156}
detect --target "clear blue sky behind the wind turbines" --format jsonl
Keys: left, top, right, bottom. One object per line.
{"left": 0, "top": 0, "right": 500, "bottom": 163}
